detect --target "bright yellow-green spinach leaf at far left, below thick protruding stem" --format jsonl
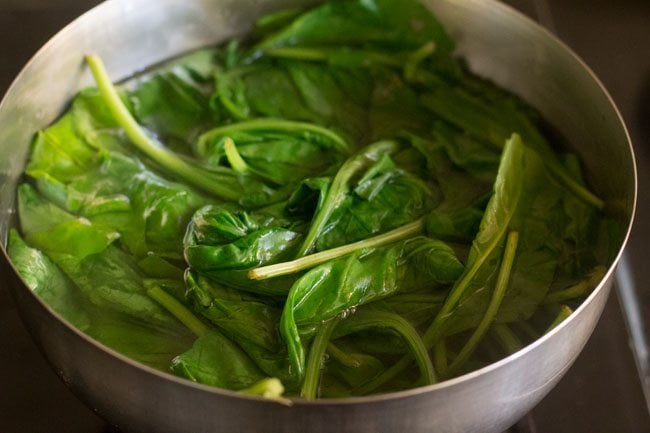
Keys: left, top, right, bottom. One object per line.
{"left": 27, "top": 87, "right": 206, "bottom": 258}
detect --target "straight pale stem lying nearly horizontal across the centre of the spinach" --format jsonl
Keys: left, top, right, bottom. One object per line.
{"left": 248, "top": 218, "right": 424, "bottom": 280}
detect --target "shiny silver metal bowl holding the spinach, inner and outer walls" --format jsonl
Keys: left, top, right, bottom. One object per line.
{"left": 0, "top": 0, "right": 636, "bottom": 433}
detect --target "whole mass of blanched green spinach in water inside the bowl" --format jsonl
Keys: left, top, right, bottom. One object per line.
{"left": 9, "top": 0, "right": 608, "bottom": 399}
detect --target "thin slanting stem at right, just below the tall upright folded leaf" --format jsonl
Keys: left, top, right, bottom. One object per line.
{"left": 447, "top": 231, "right": 519, "bottom": 376}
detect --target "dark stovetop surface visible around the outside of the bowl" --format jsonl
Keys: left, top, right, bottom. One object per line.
{"left": 0, "top": 0, "right": 650, "bottom": 433}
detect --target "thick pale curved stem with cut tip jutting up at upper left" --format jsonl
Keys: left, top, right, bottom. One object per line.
{"left": 86, "top": 54, "right": 240, "bottom": 200}
